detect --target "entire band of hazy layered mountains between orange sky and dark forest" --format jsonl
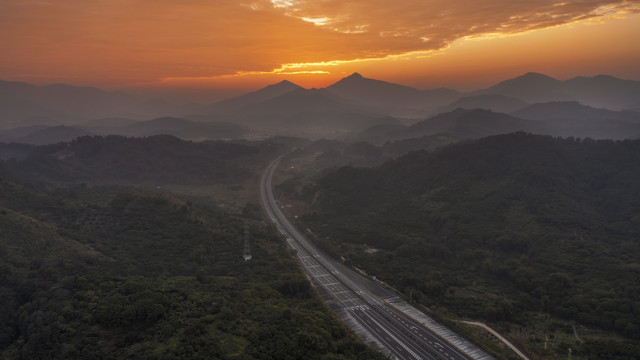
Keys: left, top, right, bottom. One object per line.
{"left": 0, "top": 73, "right": 640, "bottom": 144}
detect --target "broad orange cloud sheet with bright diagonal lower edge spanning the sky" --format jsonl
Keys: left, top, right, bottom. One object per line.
{"left": 0, "top": 0, "right": 640, "bottom": 85}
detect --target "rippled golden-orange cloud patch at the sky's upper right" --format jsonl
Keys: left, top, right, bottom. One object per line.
{"left": 272, "top": 0, "right": 640, "bottom": 47}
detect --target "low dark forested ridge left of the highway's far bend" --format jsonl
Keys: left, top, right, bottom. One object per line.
{"left": 0, "top": 135, "right": 264, "bottom": 184}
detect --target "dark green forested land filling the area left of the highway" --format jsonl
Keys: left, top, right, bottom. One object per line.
{"left": 0, "top": 136, "right": 383, "bottom": 359}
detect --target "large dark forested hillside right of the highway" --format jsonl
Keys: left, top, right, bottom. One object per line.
{"left": 279, "top": 133, "right": 640, "bottom": 359}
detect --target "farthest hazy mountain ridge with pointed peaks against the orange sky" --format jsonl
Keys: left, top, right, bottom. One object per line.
{"left": 0, "top": 72, "right": 640, "bottom": 135}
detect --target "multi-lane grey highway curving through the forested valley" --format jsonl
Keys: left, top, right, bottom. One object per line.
{"left": 260, "top": 154, "right": 493, "bottom": 360}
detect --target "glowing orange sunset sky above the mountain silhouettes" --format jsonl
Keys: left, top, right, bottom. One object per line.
{"left": 0, "top": 0, "right": 640, "bottom": 100}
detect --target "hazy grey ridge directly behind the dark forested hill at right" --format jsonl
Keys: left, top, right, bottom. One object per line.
{"left": 357, "top": 101, "right": 640, "bottom": 144}
